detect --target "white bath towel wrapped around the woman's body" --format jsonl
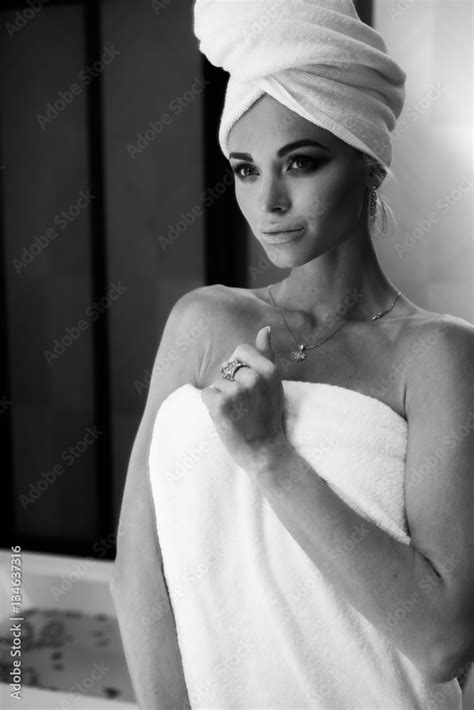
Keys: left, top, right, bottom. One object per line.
{"left": 149, "top": 380, "right": 461, "bottom": 710}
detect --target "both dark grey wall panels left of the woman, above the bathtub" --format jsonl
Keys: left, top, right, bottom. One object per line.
{"left": 0, "top": 0, "right": 205, "bottom": 557}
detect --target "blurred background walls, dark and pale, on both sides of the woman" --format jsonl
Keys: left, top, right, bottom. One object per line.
{"left": 0, "top": 0, "right": 474, "bottom": 708}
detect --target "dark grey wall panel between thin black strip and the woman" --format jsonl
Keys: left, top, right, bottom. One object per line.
{"left": 102, "top": 0, "right": 204, "bottom": 524}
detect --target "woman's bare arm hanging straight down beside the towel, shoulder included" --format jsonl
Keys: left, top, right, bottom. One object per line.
{"left": 111, "top": 289, "right": 213, "bottom": 710}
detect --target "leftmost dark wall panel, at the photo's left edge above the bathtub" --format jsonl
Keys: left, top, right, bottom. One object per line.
{"left": 0, "top": 5, "right": 98, "bottom": 544}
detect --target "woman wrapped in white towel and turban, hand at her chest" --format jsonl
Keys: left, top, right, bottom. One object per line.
{"left": 113, "top": 0, "right": 474, "bottom": 710}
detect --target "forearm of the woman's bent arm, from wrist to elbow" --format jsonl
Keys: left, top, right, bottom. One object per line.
{"left": 248, "top": 445, "right": 460, "bottom": 672}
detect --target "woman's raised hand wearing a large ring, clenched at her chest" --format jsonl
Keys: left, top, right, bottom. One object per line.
{"left": 201, "top": 327, "right": 288, "bottom": 473}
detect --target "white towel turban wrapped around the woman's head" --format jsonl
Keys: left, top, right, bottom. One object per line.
{"left": 194, "top": 0, "right": 406, "bottom": 172}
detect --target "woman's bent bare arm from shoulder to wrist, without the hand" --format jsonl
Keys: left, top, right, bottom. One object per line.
{"left": 244, "top": 322, "right": 474, "bottom": 683}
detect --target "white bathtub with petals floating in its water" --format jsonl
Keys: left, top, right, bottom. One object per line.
{"left": 0, "top": 549, "right": 138, "bottom": 710}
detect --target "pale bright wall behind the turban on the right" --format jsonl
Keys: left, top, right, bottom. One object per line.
{"left": 374, "top": 0, "right": 474, "bottom": 323}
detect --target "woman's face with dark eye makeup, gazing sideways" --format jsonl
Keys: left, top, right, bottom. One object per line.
{"left": 228, "top": 94, "right": 369, "bottom": 268}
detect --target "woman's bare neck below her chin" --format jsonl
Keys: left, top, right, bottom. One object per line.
{"left": 272, "top": 229, "right": 398, "bottom": 326}
